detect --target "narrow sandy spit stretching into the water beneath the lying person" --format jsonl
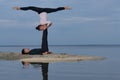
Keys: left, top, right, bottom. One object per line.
{"left": 0, "top": 52, "right": 105, "bottom": 63}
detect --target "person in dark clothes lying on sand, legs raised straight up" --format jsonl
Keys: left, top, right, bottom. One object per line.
{"left": 22, "top": 29, "right": 50, "bottom": 55}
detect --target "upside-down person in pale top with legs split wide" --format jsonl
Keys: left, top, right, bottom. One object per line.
{"left": 13, "top": 6, "right": 71, "bottom": 31}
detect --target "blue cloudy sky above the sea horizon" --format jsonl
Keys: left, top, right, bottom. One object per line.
{"left": 0, "top": 0, "right": 120, "bottom": 45}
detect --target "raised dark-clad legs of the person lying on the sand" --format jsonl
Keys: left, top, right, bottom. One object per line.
{"left": 41, "top": 29, "right": 49, "bottom": 52}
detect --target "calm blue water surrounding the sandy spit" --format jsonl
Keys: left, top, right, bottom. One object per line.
{"left": 0, "top": 46, "right": 120, "bottom": 80}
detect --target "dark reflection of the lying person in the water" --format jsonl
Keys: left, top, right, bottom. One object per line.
{"left": 22, "top": 62, "right": 49, "bottom": 80}
